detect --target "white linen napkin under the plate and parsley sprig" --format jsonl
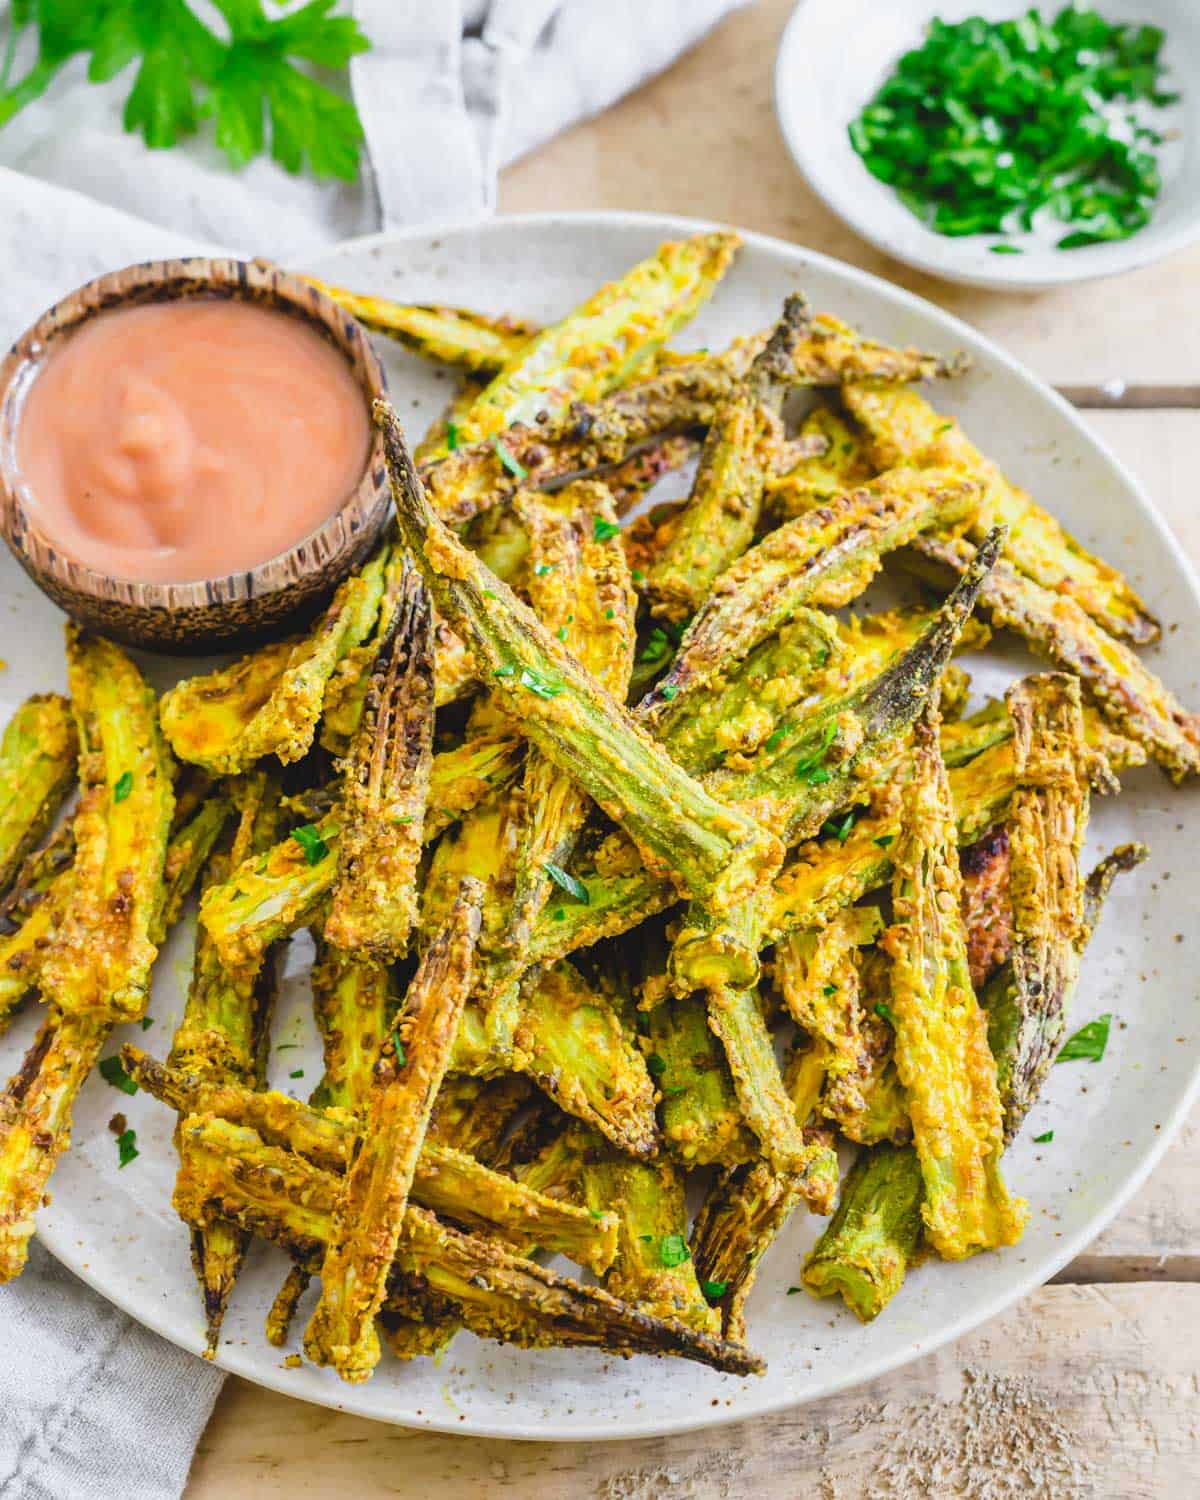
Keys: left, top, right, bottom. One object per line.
{"left": 0, "top": 0, "right": 749, "bottom": 1500}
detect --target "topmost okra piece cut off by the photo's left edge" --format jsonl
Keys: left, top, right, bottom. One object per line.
{"left": 0, "top": 693, "right": 78, "bottom": 896}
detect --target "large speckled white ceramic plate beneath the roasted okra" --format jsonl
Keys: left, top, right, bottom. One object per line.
{"left": 9, "top": 215, "right": 1200, "bottom": 1439}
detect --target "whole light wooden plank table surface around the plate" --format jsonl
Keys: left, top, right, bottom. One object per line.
{"left": 186, "top": 0, "right": 1200, "bottom": 1500}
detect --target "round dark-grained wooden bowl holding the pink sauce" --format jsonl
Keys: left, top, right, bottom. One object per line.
{"left": 0, "top": 257, "right": 390, "bottom": 654}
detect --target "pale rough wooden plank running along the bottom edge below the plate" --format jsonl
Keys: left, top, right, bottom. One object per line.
{"left": 186, "top": 1286, "right": 1200, "bottom": 1500}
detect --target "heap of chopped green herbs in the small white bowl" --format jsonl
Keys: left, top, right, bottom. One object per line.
{"left": 849, "top": 5, "right": 1175, "bottom": 255}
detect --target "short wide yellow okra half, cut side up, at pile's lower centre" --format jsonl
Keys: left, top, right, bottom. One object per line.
{"left": 513, "top": 962, "right": 659, "bottom": 1157}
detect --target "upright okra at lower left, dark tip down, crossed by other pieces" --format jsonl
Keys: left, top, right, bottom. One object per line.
{"left": 168, "top": 771, "right": 279, "bottom": 1359}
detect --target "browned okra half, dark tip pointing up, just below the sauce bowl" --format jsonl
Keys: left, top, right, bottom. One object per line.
{"left": 324, "top": 570, "right": 434, "bottom": 960}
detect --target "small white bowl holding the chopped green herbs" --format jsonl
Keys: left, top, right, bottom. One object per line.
{"left": 776, "top": 0, "right": 1200, "bottom": 291}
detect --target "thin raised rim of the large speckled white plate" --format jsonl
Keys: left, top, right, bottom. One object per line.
{"left": 39, "top": 213, "right": 1200, "bottom": 1442}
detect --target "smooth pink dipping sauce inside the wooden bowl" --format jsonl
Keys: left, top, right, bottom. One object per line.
{"left": 17, "top": 300, "right": 371, "bottom": 584}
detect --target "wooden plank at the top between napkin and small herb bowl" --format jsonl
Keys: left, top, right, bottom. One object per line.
{"left": 500, "top": 0, "right": 1200, "bottom": 401}
